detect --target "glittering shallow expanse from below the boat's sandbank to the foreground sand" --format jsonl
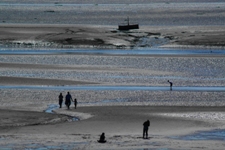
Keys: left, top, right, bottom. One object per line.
{"left": 0, "top": 49, "right": 225, "bottom": 108}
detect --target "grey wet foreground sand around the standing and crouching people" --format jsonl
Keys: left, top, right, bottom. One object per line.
{"left": 0, "top": 106, "right": 225, "bottom": 150}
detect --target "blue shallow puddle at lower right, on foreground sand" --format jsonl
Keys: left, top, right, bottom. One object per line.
{"left": 170, "top": 129, "right": 225, "bottom": 141}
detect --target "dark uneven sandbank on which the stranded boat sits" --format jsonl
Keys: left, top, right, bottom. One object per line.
{"left": 0, "top": 24, "right": 225, "bottom": 49}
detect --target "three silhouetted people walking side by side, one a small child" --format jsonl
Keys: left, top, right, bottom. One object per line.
{"left": 59, "top": 92, "right": 77, "bottom": 109}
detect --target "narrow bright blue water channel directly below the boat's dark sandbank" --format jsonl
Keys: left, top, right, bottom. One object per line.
{"left": 0, "top": 48, "right": 225, "bottom": 56}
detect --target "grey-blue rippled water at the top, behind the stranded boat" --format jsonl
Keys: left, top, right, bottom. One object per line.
{"left": 0, "top": 0, "right": 225, "bottom": 27}
